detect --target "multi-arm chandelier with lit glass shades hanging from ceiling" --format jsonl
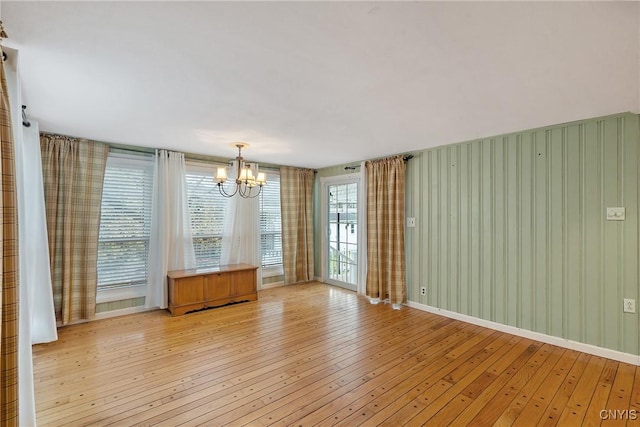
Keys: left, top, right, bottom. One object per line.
{"left": 216, "top": 142, "right": 267, "bottom": 199}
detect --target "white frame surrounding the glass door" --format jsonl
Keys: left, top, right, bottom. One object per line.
{"left": 320, "top": 172, "right": 367, "bottom": 293}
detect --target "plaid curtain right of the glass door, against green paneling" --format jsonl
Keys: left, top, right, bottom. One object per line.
{"left": 365, "top": 156, "right": 406, "bottom": 304}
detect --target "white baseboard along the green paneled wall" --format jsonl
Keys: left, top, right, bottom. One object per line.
{"left": 406, "top": 301, "right": 640, "bottom": 366}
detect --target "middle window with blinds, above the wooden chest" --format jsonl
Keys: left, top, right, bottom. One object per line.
{"left": 187, "top": 162, "right": 227, "bottom": 267}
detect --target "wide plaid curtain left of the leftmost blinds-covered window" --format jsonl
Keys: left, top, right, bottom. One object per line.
{"left": 40, "top": 134, "right": 109, "bottom": 325}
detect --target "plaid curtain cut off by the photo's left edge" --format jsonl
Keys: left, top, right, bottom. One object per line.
{"left": 0, "top": 46, "right": 19, "bottom": 426}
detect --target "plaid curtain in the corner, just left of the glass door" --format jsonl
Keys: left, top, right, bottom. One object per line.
{"left": 280, "top": 167, "right": 315, "bottom": 284}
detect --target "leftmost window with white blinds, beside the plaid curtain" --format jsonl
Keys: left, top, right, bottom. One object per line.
{"left": 98, "top": 153, "right": 153, "bottom": 302}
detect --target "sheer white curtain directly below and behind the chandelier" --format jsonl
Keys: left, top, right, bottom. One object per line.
{"left": 220, "top": 165, "right": 262, "bottom": 280}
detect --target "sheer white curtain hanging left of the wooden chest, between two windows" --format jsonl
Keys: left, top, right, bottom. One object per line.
{"left": 145, "top": 150, "right": 196, "bottom": 308}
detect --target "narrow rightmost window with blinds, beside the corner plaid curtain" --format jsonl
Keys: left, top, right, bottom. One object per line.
{"left": 260, "top": 172, "right": 282, "bottom": 275}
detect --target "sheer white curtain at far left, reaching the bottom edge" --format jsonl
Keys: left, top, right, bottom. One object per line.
{"left": 3, "top": 47, "right": 58, "bottom": 426}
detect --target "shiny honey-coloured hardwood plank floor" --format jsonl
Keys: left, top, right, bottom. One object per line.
{"left": 34, "top": 283, "right": 640, "bottom": 426}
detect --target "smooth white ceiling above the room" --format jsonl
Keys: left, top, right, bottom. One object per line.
{"left": 0, "top": 0, "right": 640, "bottom": 168}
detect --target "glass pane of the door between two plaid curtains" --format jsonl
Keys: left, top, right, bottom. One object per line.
{"left": 325, "top": 182, "right": 358, "bottom": 291}
